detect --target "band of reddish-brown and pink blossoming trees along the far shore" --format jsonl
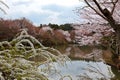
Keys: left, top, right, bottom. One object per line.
{"left": 0, "top": 18, "right": 114, "bottom": 45}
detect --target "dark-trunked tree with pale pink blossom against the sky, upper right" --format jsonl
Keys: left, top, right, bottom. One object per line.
{"left": 76, "top": 0, "right": 120, "bottom": 67}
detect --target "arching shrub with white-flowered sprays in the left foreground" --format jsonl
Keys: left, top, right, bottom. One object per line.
{"left": 0, "top": 29, "right": 69, "bottom": 80}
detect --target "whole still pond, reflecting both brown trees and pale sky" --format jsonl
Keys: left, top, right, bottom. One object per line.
{"left": 40, "top": 45, "right": 120, "bottom": 80}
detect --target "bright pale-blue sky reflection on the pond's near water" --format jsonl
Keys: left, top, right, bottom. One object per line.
{"left": 39, "top": 61, "right": 114, "bottom": 80}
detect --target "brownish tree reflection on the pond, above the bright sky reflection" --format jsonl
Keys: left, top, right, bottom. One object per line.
{"left": 53, "top": 45, "right": 102, "bottom": 61}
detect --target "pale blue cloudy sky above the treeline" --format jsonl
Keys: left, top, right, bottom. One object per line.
{"left": 0, "top": 0, "right": 82, "bottom": 25}
